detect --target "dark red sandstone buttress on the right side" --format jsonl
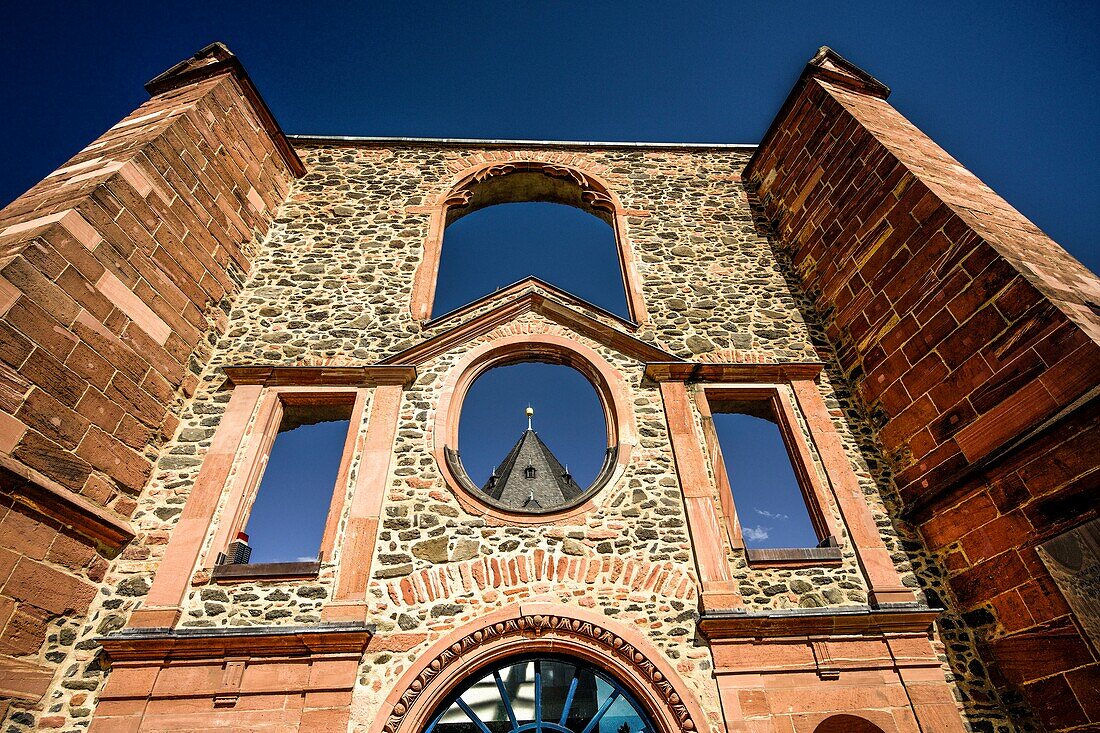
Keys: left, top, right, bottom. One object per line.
{"left": 746, "top": 48, "right": 1100, "bottom": 730}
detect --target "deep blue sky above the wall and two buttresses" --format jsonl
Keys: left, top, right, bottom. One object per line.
{"left": 0, "top": 0, "right": 1100, "bottom": 270}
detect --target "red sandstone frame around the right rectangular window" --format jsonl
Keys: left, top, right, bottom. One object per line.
{"left": 695, "top": 383, "right": 840, "bottom": 567}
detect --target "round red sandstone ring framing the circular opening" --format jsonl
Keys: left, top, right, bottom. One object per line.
{"left": 431, "top": 333, "right": 638, "bottom": 525}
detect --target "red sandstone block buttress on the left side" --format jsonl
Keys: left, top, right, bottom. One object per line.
{"left": 0, "top": 48, "right": 300, "bottom": 720}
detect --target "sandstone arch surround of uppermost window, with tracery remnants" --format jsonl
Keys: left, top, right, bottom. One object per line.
{"left": 409, "top": 156, "right": 649, "bottom": 324}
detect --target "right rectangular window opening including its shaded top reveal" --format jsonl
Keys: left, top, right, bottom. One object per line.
{"left": 708, "top": 395, "right": 834, "bottom": 548}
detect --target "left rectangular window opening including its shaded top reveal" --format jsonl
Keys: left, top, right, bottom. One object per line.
{"left": 234, "top": 394, "right": 354, "bottom": 565}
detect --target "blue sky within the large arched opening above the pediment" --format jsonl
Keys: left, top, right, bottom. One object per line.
{"left": 432, "top": 202, "right": 630, "bottom": 318}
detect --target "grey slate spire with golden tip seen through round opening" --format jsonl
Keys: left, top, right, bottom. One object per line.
{"left": 482, "top": 407, "right": 584, "bottom": 511}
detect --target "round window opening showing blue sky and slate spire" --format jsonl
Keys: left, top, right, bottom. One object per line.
{"left": 459, "top": 362, "right": 611, "bottom": 513}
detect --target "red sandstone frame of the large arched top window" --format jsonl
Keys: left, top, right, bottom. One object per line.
{"left": 407, "top": 160, "right": 649, "bottom": 325}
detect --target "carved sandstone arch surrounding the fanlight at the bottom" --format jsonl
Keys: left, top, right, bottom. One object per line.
{"left": 370, "top": 603, "right": 706, "bottom": 733}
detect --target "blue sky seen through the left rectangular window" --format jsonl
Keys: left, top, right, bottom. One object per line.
{"left": 246, "top": 419, "right": 350, "bottom": 562}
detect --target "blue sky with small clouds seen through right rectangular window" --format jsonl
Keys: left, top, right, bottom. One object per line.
{"left": 714, "top": 413, "right": 818, "bottom": 549}
